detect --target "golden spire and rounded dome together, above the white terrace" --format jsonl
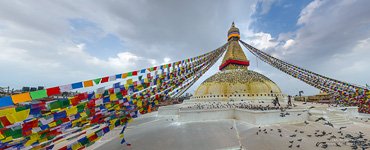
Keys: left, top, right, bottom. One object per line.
{"left": 194, "top": 22, "right": 282, "bottom": 100}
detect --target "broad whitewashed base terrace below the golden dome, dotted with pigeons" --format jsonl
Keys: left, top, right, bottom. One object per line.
{"left": 88, "top": 101, "right": 370, "bottom": 150}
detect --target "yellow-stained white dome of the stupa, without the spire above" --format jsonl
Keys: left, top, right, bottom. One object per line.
{"left": 192, "top": 69, "right": 286, "bottom": 102}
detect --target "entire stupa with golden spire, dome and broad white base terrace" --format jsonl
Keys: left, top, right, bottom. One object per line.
{"left": 57, "top": 23, "right": 370, "bottom": 150}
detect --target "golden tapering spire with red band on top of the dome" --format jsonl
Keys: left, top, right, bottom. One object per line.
{"left": 219, "top": 22, "right": 249, "bottom": 70}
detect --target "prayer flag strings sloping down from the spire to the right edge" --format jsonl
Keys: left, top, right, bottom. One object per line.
{"left": 241, "top": 41, "right": 370, "bottom": 114}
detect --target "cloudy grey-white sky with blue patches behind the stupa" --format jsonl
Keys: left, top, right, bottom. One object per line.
{"left": 0, "top": 0, "right": 370, "bottom": 95}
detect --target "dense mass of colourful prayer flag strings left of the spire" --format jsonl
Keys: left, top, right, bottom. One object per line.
{"left": 0, "top": 44, "right": 227, "bottom": 150}
